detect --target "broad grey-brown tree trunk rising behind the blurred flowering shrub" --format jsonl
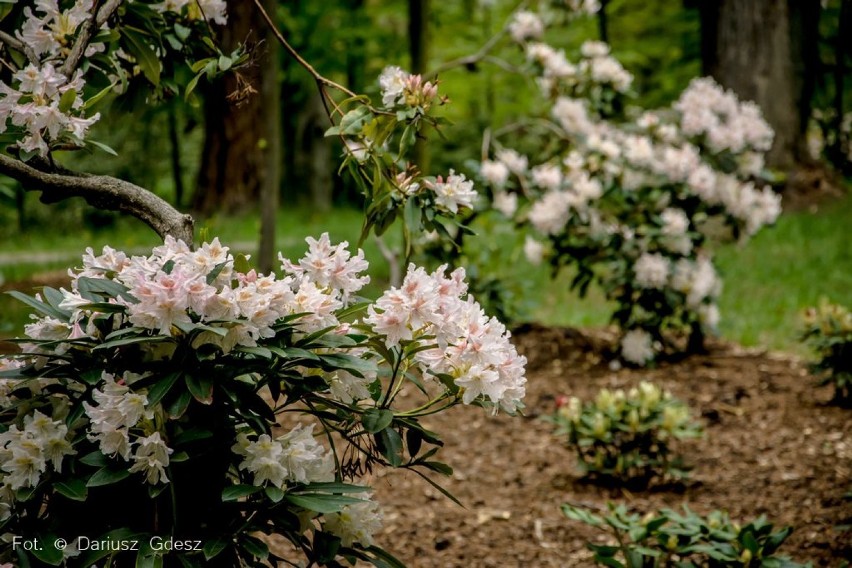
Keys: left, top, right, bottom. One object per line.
{"left": 702, "top": 0, "right": 810, "bottom": 171}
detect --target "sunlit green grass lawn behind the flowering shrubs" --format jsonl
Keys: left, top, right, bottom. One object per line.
{"left": 0, "top": 196, "right": 852, "bottom": 353}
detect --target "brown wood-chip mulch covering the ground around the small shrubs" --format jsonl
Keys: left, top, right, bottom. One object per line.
{"left": 370, "top": 326, "right": 852, "bottom": 567}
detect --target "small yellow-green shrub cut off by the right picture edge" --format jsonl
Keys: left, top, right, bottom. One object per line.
{"left": 801, "top": 302, "right": 852, "bottom": 405}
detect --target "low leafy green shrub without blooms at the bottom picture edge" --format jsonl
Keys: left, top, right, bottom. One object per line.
{"left": 562, "top": 503, "right": 811, "bottom": 568}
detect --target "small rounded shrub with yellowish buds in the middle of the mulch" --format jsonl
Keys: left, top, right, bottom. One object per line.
{"left": 548, "top": 382, "right": 702, "bottom": 484}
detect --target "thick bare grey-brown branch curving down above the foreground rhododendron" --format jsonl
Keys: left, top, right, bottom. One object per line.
{"left": 0, "top": 154, "right": 194, "bottom": 244}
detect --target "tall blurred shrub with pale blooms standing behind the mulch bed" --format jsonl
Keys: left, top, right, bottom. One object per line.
{"left": 479, "top": 5, "right": 780, "bottom": 365}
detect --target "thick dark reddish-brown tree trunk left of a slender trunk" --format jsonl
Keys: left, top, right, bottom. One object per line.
{"left": 193, "top": 0, "right": 266, "bottom": 213}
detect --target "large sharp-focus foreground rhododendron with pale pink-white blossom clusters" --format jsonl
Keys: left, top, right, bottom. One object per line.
{"left": 0, "top": 234, "right": 526, "bottom": 566}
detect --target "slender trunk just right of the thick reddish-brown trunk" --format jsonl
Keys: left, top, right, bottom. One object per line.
{"left": 257, "top": 0, "right": 282, "bottom": 273}
